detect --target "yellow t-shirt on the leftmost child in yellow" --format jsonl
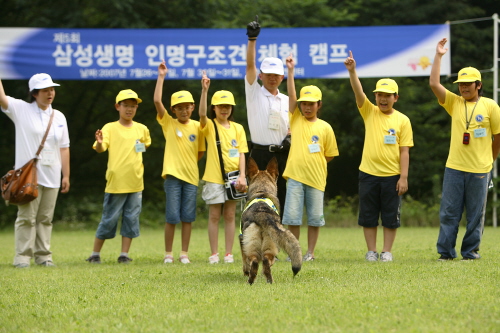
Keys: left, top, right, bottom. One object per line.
{"left": 93, "top": 121, "right": 151, "bottom": 193}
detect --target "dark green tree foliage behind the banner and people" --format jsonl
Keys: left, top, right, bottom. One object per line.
{"left": 0, "top": 0, "right": 500, "bottom": 227}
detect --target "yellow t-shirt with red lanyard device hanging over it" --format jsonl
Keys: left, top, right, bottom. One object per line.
{"left": 441, "top": 90, "right": 500, "bottom": 173}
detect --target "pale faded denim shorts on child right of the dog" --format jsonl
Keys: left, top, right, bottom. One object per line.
{"left": 282, "top": 178, "right": 325, "bottom": 227}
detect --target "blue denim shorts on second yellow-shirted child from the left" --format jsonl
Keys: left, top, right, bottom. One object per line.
{"left": 163, "top": 176, "right": 198, "bottom": 224}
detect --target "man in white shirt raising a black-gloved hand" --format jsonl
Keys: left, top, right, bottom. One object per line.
{"left": 245, "top": 16, "right": 290, "bottom": 216}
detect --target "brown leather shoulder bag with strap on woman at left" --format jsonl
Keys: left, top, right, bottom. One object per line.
{"left": 0, "top": 111, "right": 54, "bottom": 205}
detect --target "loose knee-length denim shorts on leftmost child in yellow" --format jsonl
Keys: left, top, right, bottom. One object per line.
{"left": 95, "top": 192, "right": 142, "bottom": 239}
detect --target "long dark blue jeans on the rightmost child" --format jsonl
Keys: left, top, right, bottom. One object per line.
{"left": 437, "top": 168, "right": 489, "bottom": 259}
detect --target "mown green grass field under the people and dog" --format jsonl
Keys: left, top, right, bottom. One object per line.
{"left": 0, "top": 226, "right": 500, "bottom": 332}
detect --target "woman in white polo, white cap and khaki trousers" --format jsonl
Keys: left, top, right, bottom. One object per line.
{"left": 0, "top": 74, "right": 69, "bottom": 268}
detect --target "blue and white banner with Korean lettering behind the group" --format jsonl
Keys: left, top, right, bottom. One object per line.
{"left": 0, "top": 24, "right": 451, "bottom": 80}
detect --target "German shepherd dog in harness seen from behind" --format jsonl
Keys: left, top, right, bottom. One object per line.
{"left": 240, "top": 157, "right": 302, "bottom": 284}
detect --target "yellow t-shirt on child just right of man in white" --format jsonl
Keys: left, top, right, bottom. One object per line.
{"left": 283, "top": 107, "right": 339, "bottom": 191}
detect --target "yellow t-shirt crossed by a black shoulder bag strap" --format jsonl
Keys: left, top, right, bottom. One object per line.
{"left": 202, "top": 119, "right": 248, "bottom": 184}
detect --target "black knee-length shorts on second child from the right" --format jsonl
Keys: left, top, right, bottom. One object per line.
{"left": 358, "top": 171, "right": 401, "bottom": 229}
